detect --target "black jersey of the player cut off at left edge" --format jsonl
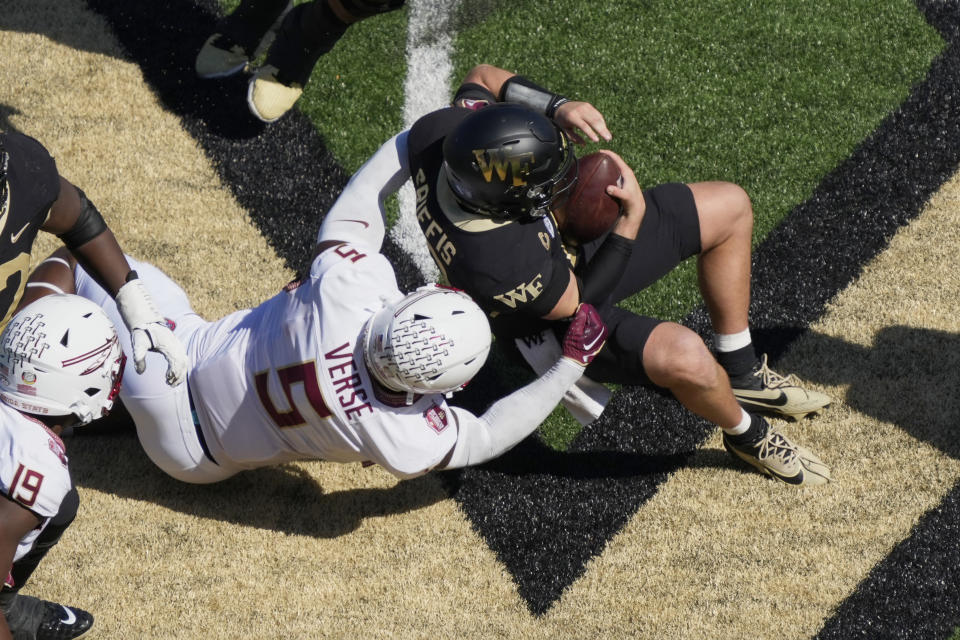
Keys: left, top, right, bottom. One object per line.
{"left": 0, "top": 133, "right": 60, "bottom": 328}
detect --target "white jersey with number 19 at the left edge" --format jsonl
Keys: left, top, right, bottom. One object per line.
{"left": 0, "top": 401, "right": 72, "bottom": 564}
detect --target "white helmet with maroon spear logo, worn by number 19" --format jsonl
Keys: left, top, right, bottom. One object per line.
{"left": 0, "top": 294, "right": 126, "bottom": 424}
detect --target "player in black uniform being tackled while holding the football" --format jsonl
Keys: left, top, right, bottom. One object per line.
{"left": 345, "top": 65, "right": 830, "bottom": 485}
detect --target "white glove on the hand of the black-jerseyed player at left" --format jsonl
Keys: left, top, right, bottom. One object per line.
{"left": 116, "top": 277, "right": 188, "bottom": 387}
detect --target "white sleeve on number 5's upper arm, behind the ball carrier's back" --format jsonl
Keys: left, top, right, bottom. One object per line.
{"left": 317, "top": 131, "right": 410, "bottom": 251}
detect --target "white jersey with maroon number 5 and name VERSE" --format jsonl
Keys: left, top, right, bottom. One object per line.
{"left": 190, "top": 244, "right": 457, "bottom": 476}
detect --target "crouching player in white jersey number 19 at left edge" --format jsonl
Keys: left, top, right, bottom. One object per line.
{"left": 0, "top": 295, "right": 125, "bottom": 640}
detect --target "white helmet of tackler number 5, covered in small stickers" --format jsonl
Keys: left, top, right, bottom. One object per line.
{"left": 363, "top": 285, "right": 490, "bottom": 402}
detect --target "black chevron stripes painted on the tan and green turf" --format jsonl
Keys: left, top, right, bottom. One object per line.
{"left": 88, "top": 0, "right": 960, "bottom": 624}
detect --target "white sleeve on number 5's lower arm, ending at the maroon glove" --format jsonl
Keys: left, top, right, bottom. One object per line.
{"left": 447, "top": 358, "right": 583, "bottom": 469}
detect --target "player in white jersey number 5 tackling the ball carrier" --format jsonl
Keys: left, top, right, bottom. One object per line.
{"left": 20, "top": 134, "right": 607, "bottom": 483}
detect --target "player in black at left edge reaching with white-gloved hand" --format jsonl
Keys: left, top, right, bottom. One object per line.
{"left": 0, "top": 132, "right": 187, "bottom": 385}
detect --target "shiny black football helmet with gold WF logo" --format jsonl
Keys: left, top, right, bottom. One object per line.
{"left": 443, "top": 102, "right": 577, "bottom": 219}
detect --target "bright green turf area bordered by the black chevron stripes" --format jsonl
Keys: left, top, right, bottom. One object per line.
{"left": 216, "top": 0, "right": 943, "bottom": 449}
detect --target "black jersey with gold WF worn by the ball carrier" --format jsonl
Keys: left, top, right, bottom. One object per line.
{"left": 407, "top": 101, "right": 570, "bottom": 336}
